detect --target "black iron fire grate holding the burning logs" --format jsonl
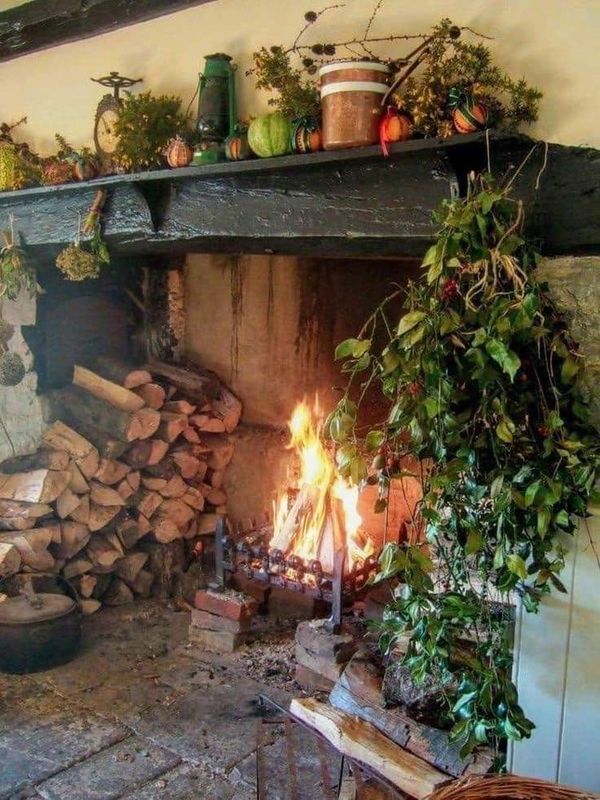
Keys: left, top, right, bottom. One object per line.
{"left": 215, "top": 518, "right": 377, "bottom": 633}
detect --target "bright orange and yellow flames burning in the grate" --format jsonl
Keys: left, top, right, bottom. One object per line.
{"left": 271, "top": 398, "right": 373, "bottom": 570}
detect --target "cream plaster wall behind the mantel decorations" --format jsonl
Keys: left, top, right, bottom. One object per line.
{"left": 0, "top": 0, "right": 600, "bottom": 152}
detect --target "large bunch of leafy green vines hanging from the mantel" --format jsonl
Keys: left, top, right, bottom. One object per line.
{"left": 326, "top": 176, "right": 600, "bottom": 755}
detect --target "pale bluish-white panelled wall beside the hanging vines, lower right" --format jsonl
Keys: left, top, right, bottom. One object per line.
{"left": 509, "top": 517, "right": 600, "bottom": 792}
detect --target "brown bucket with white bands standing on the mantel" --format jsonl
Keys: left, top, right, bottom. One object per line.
{"left": 319, "top": 61, "right": 390, "bottom": 150}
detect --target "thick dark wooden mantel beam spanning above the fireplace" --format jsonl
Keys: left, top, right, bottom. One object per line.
{"left": 0, "top": 132, "right": 600, "bottom": 258}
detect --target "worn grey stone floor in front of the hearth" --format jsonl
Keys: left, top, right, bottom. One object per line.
{"left": 0, "top": 601, "right": 339, "bottom": 800}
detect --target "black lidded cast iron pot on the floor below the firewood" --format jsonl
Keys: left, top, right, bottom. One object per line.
{"left": 0, "top": 575, "right": 81, "bottom": 675}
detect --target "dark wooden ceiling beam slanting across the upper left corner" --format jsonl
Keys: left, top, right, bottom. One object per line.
{"left": 0, "top": 0, "right": 215, "bottom": 61}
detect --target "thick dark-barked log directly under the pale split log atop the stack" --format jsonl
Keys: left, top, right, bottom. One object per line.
{"left": 55, "top": 386, "right": 143, "bottom": 444}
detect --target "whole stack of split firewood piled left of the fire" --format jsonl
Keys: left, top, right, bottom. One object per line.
{"left": 0, "top": 358, "right": 241, "bottom": 613}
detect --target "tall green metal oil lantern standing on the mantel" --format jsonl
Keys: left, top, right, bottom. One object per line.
{"left": 193, "top": 53, "right": 237, "bottom": 164}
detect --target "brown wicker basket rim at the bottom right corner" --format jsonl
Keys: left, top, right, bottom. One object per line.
{"left": 428, "top": 775, "right": 600, "bottom": 800}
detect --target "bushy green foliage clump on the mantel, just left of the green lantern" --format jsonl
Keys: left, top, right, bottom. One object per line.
{"left": 115, "top": 92, "right": 186, "bottom": 172}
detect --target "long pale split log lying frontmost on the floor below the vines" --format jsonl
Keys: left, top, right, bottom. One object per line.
{"left": 290, "top": 698, "right": 448, "bottom": 800}
